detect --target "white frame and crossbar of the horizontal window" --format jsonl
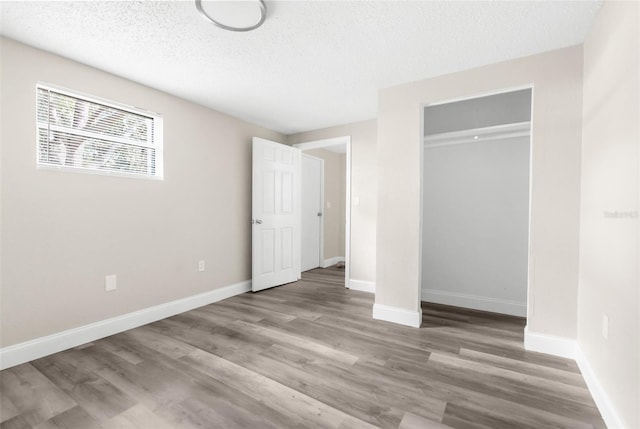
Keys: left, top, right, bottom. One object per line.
{"left": 35, "top": 82, "right": 164, "bottom": 180}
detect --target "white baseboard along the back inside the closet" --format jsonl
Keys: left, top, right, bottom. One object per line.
{"left": 422, "top": 289, "right": 527, "bottom": 317}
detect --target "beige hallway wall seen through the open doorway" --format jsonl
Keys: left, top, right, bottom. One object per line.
{"left": 304, "top": 149, "right": 347, "bottom": 259}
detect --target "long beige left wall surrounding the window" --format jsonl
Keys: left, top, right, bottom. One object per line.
{"left": 0, "top": 39, "right": 284, "bottom": 347}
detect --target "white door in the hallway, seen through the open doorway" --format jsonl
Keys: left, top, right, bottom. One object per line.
{"left": 301, "top": 154, "right": 324, "bottom": 271}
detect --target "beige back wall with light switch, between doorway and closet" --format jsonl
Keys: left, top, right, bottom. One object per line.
{"left": 287, "top": 120, "right": 377, "bottom": 283}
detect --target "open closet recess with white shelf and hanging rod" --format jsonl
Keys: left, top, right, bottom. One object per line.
{"left": 421, "top": 88, "right": 532, "bottom": 317}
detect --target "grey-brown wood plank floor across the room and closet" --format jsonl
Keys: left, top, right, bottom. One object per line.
{"left": 0, "top": 268, "right": 605, "bottom": 429}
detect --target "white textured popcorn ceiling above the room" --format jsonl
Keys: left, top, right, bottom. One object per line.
{"left": 0, "top": 0, "right": 601, "bottom": 134}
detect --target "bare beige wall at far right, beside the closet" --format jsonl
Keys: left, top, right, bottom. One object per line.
{"left": 578, "top": 2, "right": 640, "bottom": 428}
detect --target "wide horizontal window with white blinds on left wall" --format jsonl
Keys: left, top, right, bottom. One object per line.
{"left": 36, "top": 84, "right": 163, "bottom": 179}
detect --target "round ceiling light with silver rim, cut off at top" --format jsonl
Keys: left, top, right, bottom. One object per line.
{"left": 195, "top": 0, "right": 267, "bottom": 31}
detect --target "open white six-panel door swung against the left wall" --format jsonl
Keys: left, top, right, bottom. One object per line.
{"left": 251, "top": 137, "right": 301, "bottom": 292}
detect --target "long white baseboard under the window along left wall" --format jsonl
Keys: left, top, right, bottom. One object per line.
{"left": 0, "top": 281, "right": 251, "bottom": 369}
